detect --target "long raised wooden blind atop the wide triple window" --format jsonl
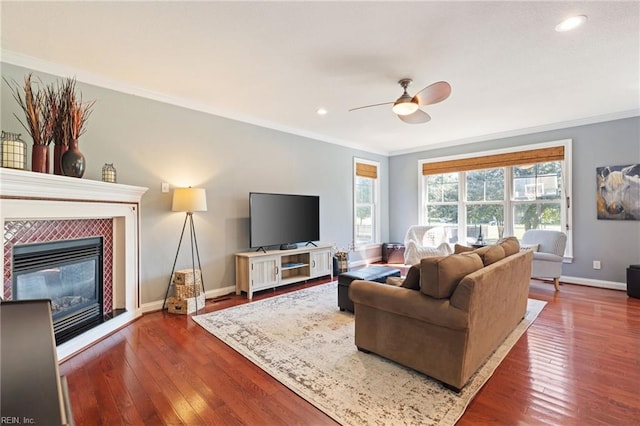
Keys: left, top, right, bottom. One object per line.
{"left": 422, "top": 146, "right": 564, "bottom": 175}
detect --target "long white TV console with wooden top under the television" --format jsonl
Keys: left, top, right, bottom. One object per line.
{"left": 235, "top": 244, "right": 333, "bottom": 299}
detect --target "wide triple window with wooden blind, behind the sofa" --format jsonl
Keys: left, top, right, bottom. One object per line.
{"left": 420, "top": 140, "right": 572, "bottom": 257}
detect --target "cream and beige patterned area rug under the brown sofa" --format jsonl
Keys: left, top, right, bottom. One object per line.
{"left": 193, "top": 282, "right": 546, "bottom": 425}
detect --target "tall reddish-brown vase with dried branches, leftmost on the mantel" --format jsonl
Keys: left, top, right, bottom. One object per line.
{"left": 4, "top": 74, "right": 58, "bottom": 173}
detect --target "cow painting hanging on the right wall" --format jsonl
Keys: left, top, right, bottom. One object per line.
{"left": 596, "top": 164, "right": 640, "bottom": 220}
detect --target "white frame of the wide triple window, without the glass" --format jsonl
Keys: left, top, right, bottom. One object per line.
{"left": 418, "top": 139, "right": 573, "bottom": 262}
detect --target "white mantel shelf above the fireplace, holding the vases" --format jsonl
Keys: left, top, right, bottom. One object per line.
{"left": 0, "top": 168, "right": 148, "bottom": 203}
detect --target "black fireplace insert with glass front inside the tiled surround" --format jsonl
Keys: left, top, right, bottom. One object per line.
{"left": 12, "top": 237, "right": 104, "bottom": 345}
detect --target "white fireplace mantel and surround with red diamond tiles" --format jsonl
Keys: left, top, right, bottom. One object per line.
{"left": 0, "top": 168, "right": 147, "bottom": 360}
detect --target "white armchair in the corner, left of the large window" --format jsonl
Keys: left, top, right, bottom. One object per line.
{"left": 404, "top": 225, "right": 453, "bottom": 265}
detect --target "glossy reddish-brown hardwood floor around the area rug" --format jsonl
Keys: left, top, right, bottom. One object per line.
{"left": 61, "top": 274, "right": 640, "bottom": 425}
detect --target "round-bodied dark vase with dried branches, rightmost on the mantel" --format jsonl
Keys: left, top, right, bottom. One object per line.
{"left": 55, "top": 78, "right": 95, "bottom": 177}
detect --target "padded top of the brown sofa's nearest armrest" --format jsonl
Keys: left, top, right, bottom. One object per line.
{"left": 349, "top": 280, "right": 468, "bottom": 330}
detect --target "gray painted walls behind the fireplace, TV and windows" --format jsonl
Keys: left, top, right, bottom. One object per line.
{"left": 0, "top": 63, "right": 640, "bottom": 292}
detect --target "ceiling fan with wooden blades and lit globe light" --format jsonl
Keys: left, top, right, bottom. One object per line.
{"left": 349, "top": 78, "right": 451, "bottom": 124}
